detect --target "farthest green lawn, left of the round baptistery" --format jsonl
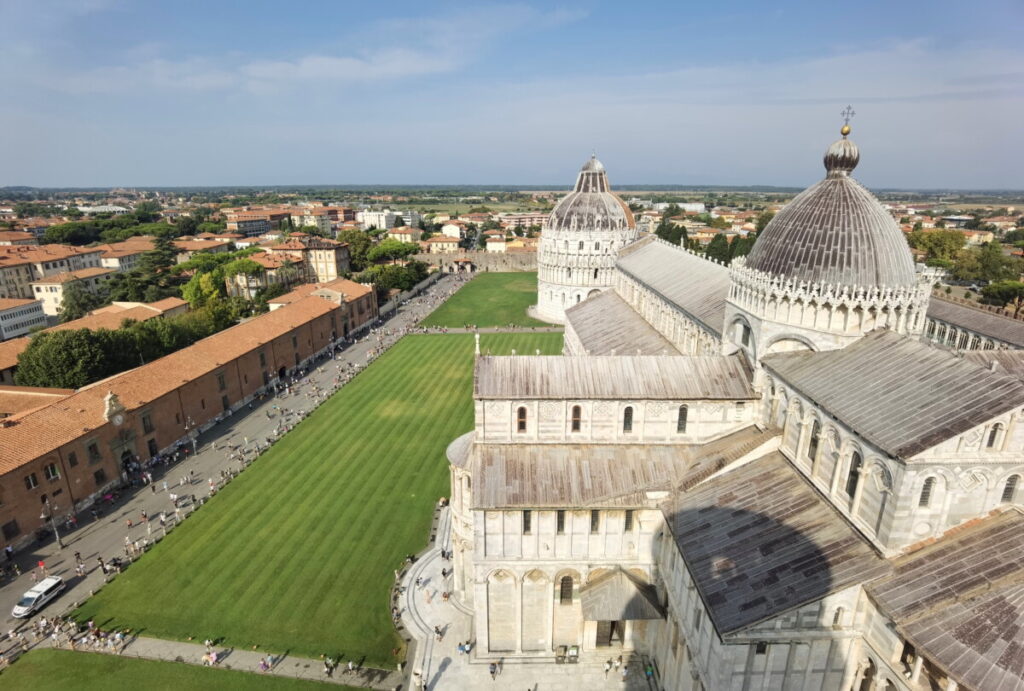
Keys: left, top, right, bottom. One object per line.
{"left": 421, "top": 271, "right": 549, "bottom": 328}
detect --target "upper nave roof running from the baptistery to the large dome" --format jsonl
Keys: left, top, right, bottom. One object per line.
{"left": 615, "top": 237, "right": 730, "bottom": 337}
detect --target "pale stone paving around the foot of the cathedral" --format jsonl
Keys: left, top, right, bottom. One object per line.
{"left": 398, "top": 508, "right": 653, "bottom": 691}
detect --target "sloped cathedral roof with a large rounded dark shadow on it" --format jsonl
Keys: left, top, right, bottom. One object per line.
{"left": 662, "top": 451, "right": 889, "bottom": 635}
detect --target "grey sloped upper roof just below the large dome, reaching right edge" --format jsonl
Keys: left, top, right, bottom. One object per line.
{"left": 762, "top": 330, "right": 1024, "bottom": 460}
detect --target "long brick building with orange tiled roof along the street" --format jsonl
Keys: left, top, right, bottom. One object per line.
{"left": 0, "top": 291, "right": 377, "bottom": 546}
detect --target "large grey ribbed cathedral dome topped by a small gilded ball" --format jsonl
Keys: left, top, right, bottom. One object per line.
{"left": 745, "top": 126, "right": 916, "bottom": 288}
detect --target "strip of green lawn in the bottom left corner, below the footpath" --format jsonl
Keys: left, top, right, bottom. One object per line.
{"left": 0, "top": 648, "right": 344, "bottom": 691}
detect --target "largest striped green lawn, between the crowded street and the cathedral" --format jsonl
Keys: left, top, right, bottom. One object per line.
{"left": 77, "top": 334, "right": 562, "bottom": 668}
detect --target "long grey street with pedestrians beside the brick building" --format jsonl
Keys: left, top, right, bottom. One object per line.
{"left": 0, "top": 275, "right": 463, "bottom": 638}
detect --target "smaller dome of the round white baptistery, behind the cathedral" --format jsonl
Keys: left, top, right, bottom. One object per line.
{"left": 544, "top": 156, "right": 636, "bottom": 231}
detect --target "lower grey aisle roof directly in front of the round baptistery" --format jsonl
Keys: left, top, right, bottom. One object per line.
{"left": 565, "top": 291, "right": 679, "bottom": 355}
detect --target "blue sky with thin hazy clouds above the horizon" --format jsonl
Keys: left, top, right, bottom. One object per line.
{"left": 0, "top": 0, "right": 1024, "bottom": 189}
